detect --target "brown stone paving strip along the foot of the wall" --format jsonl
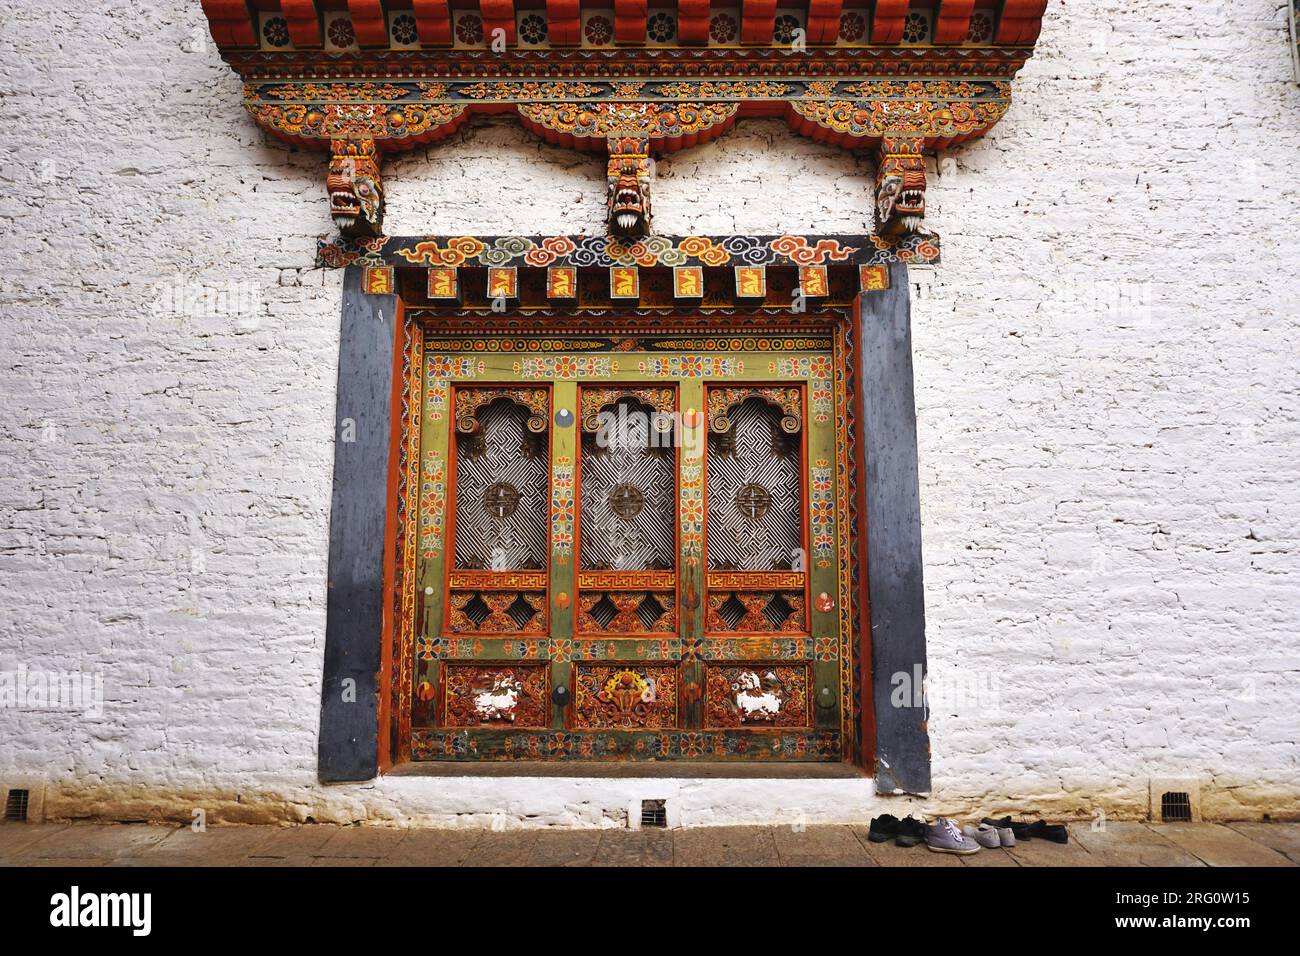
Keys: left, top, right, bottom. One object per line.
{"left": 0, "top": 823, "right": 1300, "bottom": 866}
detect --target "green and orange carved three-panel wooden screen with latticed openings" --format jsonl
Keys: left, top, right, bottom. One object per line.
{"left": 410, "top": 334, "right": 852, "bottom": 761}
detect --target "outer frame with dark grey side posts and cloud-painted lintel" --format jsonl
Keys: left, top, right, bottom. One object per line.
{"left": 319, "top": 247, "right": 930, "bottom": 792}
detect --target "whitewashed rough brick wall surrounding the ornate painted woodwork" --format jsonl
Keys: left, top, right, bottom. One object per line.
{"left": 0, "top": 0, "right": 1300, "bottom": 825}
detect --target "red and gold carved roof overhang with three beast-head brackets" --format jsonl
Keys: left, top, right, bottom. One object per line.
{"left": 200, "top": 0, "right": 1047, "bottom": 247}
